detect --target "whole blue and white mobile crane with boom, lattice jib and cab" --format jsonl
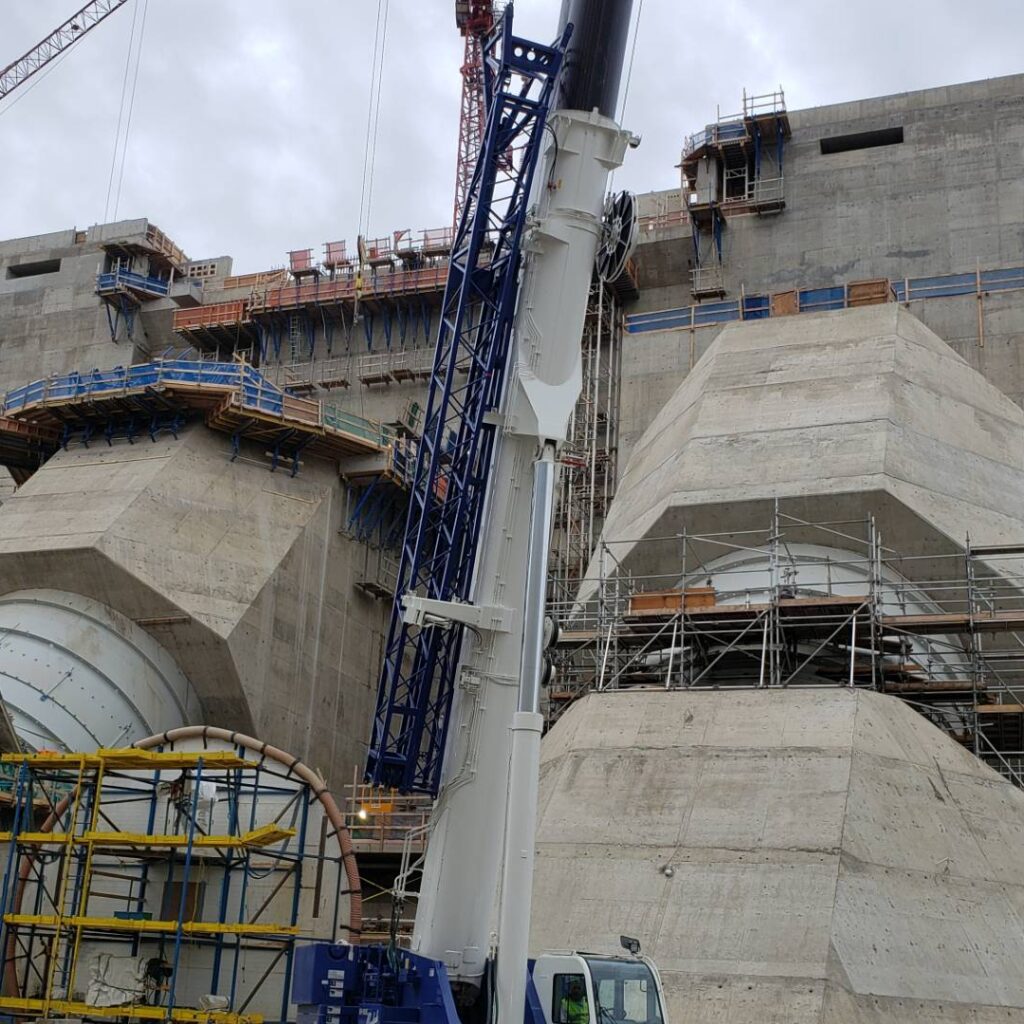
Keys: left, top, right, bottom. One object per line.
{"left": 295, "top": 0, "right": 664, "bottom": 1024}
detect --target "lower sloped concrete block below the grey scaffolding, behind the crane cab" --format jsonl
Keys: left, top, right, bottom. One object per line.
{"left": 532, "top": 689, "right": 1024, "bottom": 1024}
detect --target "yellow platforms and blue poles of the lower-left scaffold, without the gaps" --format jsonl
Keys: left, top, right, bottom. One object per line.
{"left": 0, "top": 749, "right": 319, "bottom": 1024}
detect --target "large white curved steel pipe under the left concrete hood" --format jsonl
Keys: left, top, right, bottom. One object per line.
{"left": 0, "top": 590, "right": 200, "bottom": 751}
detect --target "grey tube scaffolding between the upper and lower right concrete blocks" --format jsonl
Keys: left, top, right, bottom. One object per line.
{"left": 549, "top": 503, "right": 1024, "bottom": 784}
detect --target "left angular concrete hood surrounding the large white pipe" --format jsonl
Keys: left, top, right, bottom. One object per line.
{"left": 0, "top": 424, "right": 383, "bottom": 784}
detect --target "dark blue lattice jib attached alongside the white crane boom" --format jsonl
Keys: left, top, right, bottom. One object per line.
{"left": 367, "top": 5, "right": 570, "bottom": 795}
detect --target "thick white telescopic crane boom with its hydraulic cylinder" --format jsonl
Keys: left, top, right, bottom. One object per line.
{"left": 413, "top": 0, "right": 632, "bottom": 999}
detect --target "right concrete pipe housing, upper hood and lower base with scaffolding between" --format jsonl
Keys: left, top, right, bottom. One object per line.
{"left": 534, "top": 304, "right": 1024, "bottom": 1022}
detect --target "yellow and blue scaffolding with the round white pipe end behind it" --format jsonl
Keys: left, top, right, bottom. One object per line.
{"left": 0, "top": 748, "right": 342, "bottom": 1024}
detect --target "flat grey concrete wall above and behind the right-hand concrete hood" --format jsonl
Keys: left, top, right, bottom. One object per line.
{"left": 620, "top": 76, "right": 1024, "bottom": 465}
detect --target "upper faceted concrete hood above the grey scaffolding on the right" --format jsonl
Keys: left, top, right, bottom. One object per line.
{"left": 602, "top": 303, "right": 1024, "bottom": 589}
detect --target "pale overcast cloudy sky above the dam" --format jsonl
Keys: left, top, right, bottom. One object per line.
{"left": 0, "top": 0, "right": 1024, "bottom": 272}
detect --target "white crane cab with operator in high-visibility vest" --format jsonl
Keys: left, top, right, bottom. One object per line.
{"left": 534, "top": 937, "right": 666, "bottom": 1024}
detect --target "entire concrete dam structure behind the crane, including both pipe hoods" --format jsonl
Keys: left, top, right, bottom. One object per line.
{"left": 0, "top": 68, "right": 1024, "bottom": 1024}
